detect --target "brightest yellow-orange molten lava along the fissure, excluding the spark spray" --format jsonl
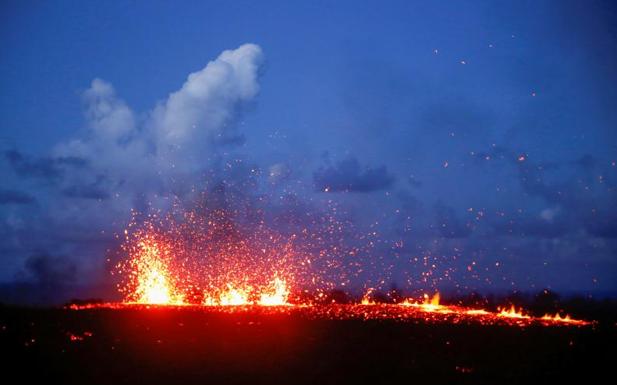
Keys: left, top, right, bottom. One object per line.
{"left": 113, "top": 236, "right": 589, "bottom": 326}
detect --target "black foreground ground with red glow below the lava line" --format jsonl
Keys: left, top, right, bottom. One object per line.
{"left": 0, "top": 307, "right": 617, "bottom": 384}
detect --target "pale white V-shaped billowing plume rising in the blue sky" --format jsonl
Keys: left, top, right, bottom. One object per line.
{"left": 53, "top": 44, "right": 263, "bottom": 196}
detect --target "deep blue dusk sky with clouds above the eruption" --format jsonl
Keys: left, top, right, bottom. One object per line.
{"left": 0, "top": 1, "right": 617, "bottom": 302}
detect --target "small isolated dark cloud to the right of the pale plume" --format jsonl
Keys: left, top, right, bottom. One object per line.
{"left": 313, "top": 158, "right": 395, "bottom": 192}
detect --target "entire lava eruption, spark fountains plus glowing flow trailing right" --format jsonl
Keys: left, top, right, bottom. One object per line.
{"left": 106, "top": 214, "right": 592, "bottom": 326}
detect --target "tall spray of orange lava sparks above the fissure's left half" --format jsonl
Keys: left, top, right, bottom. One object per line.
{"left": 113, "top": 211, "right": 304, "bottom": 306}
